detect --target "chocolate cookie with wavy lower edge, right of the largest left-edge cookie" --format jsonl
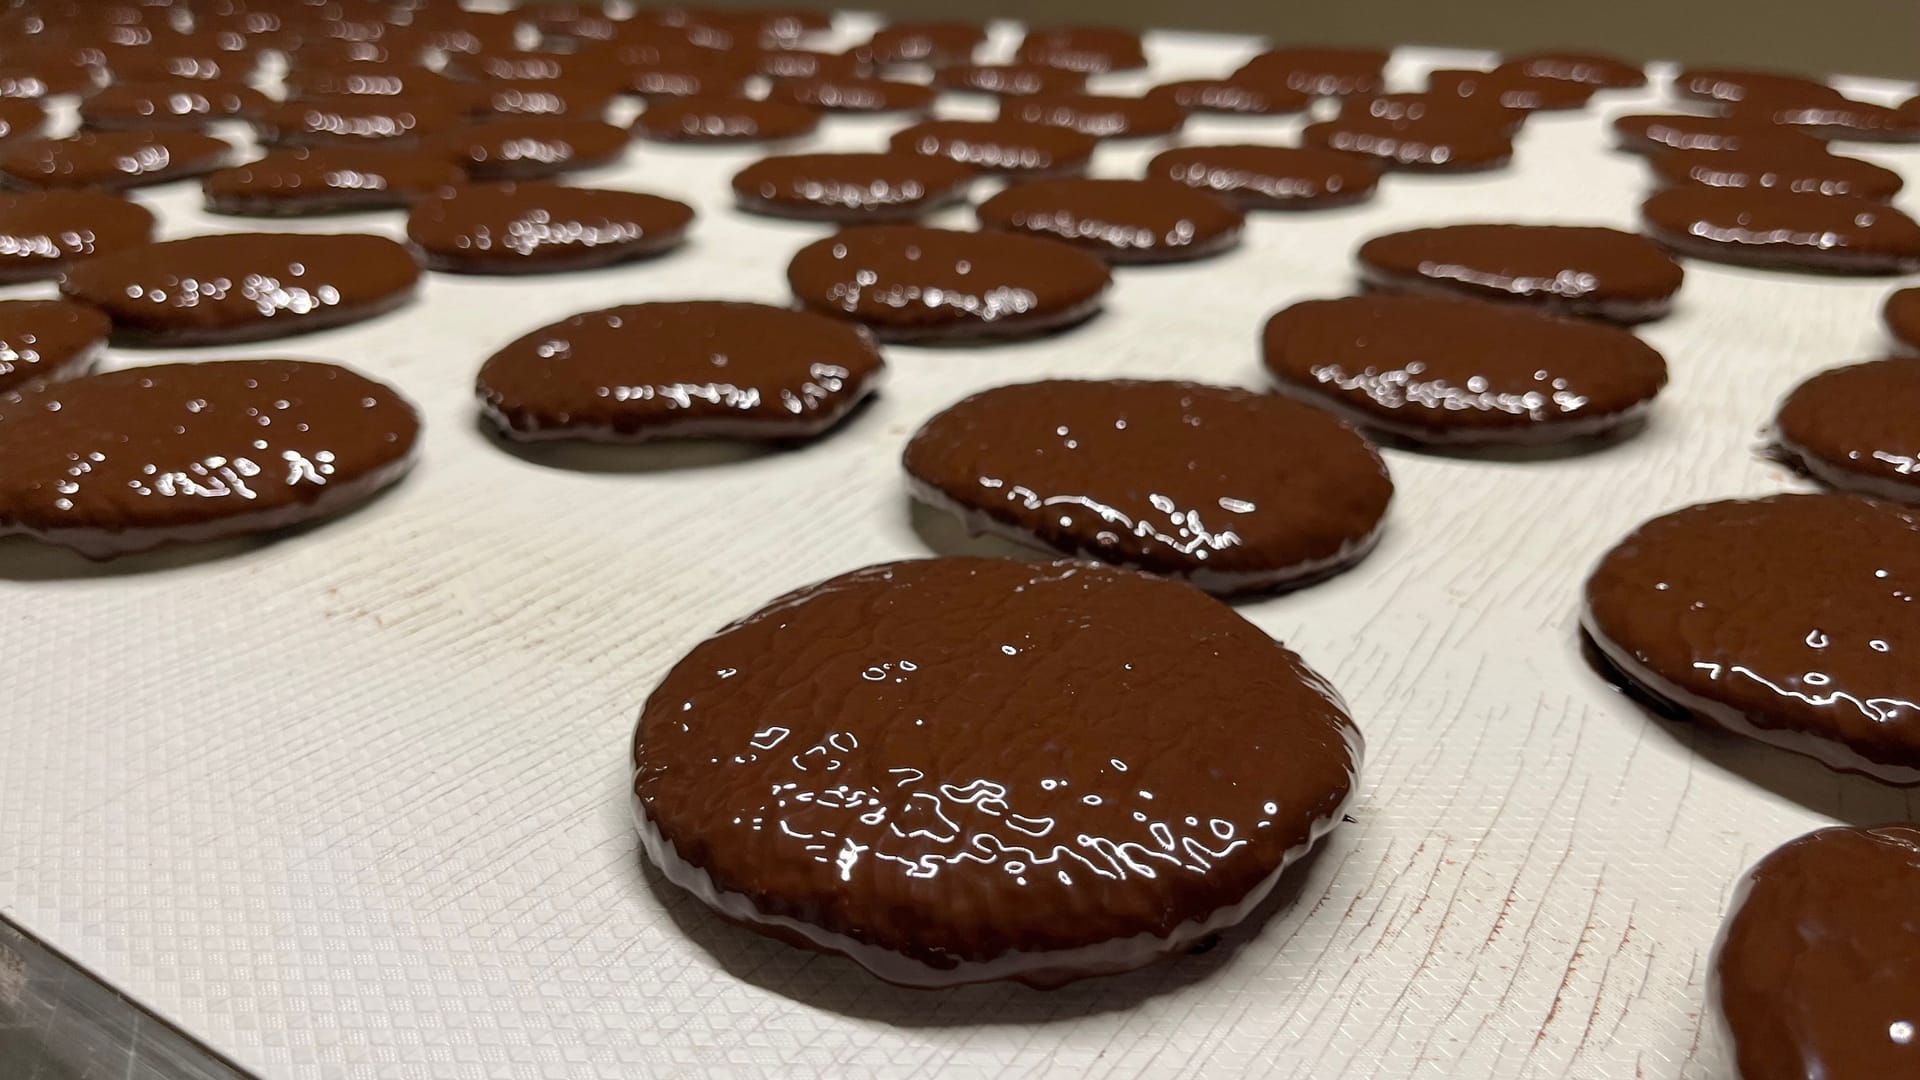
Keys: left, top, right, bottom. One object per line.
{"left": 480, "top": 300, "right": 883, "bottom": 442}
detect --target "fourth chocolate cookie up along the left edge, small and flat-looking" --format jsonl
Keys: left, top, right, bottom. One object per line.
{"left": 0, "top": 131, "right": 232, "bottom": 190}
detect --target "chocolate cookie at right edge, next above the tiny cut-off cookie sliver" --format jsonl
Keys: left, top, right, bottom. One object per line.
{"left": 1640, "top": 186, "right": 1920, "bottom": 273}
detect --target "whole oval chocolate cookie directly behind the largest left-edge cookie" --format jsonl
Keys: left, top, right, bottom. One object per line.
{"left": 60, "top": 233, "right": 420, "bottom": 346}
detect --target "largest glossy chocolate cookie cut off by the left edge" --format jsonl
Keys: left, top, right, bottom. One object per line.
{"left": 0, "top": 359, "right": 420, "bottom": 559}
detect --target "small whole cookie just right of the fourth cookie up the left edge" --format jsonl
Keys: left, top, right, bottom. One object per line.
{"left": 200, "top": 146, "right": 467, "bottom": 217}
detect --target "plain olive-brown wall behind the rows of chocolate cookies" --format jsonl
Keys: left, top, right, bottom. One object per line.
{"left": 702, "top": 0, "right": 1920, "bottom": 79}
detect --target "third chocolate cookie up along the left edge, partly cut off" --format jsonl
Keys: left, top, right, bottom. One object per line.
{"left": 0, "top": 190, "right": 154, "bottom": 282}
